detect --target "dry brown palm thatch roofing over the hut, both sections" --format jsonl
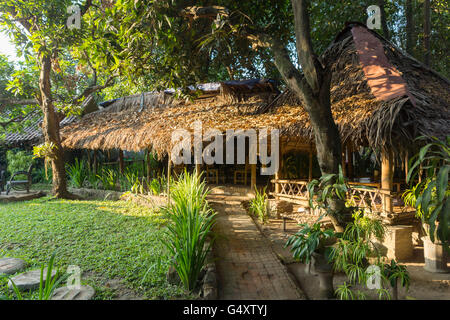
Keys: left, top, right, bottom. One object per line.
{"left": 62, "top": 24, "right": 450, "bottom": 155}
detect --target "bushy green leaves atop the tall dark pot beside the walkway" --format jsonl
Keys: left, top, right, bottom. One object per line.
{"left": 285, "top": 222, "right": 335, "bottom": 263}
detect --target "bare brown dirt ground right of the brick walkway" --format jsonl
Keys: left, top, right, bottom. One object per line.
{"left": 253, "top": 215, "right": 450, "bottom": 300}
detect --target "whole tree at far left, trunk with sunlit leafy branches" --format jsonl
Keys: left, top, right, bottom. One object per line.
{"left": 0, "top": 0, "right": 111, "bottom": 198}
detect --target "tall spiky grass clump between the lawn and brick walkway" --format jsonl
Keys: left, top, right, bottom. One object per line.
{"left": 163, "top": 171, "right": 215, "bottom": 291}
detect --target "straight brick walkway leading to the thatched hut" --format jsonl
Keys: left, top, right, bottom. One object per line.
{"left": 209, "top": 195, "right": 305, "bottom": 300}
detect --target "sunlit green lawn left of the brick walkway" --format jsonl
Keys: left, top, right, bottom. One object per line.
{"left": 0, "top": 197, "right": 183, "bottom": 299}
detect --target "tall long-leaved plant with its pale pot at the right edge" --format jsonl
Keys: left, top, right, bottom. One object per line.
{"left": 403, "top": 137, "right": 450, "bottom": 272}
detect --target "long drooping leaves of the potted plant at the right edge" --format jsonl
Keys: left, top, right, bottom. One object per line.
{"left": 403, "top": 136, "right": 450, "bottom": 250}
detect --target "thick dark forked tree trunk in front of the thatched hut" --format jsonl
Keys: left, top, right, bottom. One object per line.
{"left": 272, "top": 0, "right": 348, "bottom": 232}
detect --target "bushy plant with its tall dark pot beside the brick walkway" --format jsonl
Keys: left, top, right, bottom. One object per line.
{"left": 285, "top": 222, "right": 335, "bottom": 299}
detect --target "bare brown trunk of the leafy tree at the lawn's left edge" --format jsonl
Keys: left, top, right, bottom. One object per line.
{"left": 39, "top": 53, "right": 71, "bottom": 198}
